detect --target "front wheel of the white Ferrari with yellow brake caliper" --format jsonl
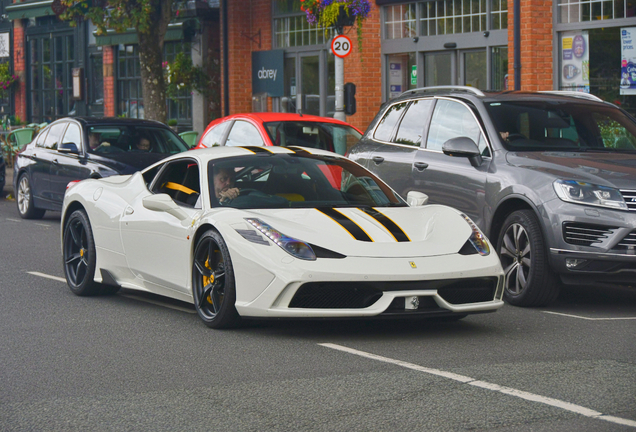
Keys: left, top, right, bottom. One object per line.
{"left": 192, "top": 230, "right": 240, "bottom": 329}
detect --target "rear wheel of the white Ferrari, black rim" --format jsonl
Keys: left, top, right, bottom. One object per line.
{"left": 62, "top": 210, "right": 119, "bottom": 296}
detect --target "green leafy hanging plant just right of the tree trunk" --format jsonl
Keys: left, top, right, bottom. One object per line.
{"left": 163, "top": 52, "right": 210, "bottom": 98}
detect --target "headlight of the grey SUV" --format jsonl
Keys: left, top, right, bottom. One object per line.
{"left": 553, "top": 179, "right": 628, "bottom": 210}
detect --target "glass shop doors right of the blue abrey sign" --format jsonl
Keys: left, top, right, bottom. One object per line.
{"left": 279, "top": 50, "right": 336, "bottom": 117}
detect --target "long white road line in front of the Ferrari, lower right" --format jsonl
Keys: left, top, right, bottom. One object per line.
{"left": 318, "top": 343, "right": 636, "bottom": 427}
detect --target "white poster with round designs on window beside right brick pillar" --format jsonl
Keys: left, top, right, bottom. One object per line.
{"left": 561, "top": 31, "right": 590, "bottom": 93}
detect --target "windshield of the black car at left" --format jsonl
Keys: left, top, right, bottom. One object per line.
{"left": 87, "top": 125, "right": 188, "bottom": 154}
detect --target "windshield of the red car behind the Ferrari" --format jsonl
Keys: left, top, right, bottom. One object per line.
{"left": 264, "top": 120, "right": 362, "bottom": 155}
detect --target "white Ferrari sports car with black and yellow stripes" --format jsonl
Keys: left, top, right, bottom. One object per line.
{"left": 62, "top": 147, "right": 504, "bottom": 328}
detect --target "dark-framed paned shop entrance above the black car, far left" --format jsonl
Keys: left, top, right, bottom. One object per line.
{"left": 27, "top": 31, "right": 76, "bottom": 123}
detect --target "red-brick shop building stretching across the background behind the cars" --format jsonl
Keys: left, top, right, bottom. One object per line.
{"left": 0, "top": 0, "right": 636, "bottom": 131}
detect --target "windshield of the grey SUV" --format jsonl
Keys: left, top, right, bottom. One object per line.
{"left": 486, "top": 101, "right": 636, "bottom": 151}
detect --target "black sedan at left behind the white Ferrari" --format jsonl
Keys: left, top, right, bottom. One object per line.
{"left": 13, "top": 117, "right": 188, "bottom": 219}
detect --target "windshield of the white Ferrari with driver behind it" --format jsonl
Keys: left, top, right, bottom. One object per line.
{"left": 208, "top": 151, "right": 406, "bottom": 209}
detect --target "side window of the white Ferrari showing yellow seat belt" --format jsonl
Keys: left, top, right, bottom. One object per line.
{"left": 152, "top": 159, "right": 201, "bottom": 208}
